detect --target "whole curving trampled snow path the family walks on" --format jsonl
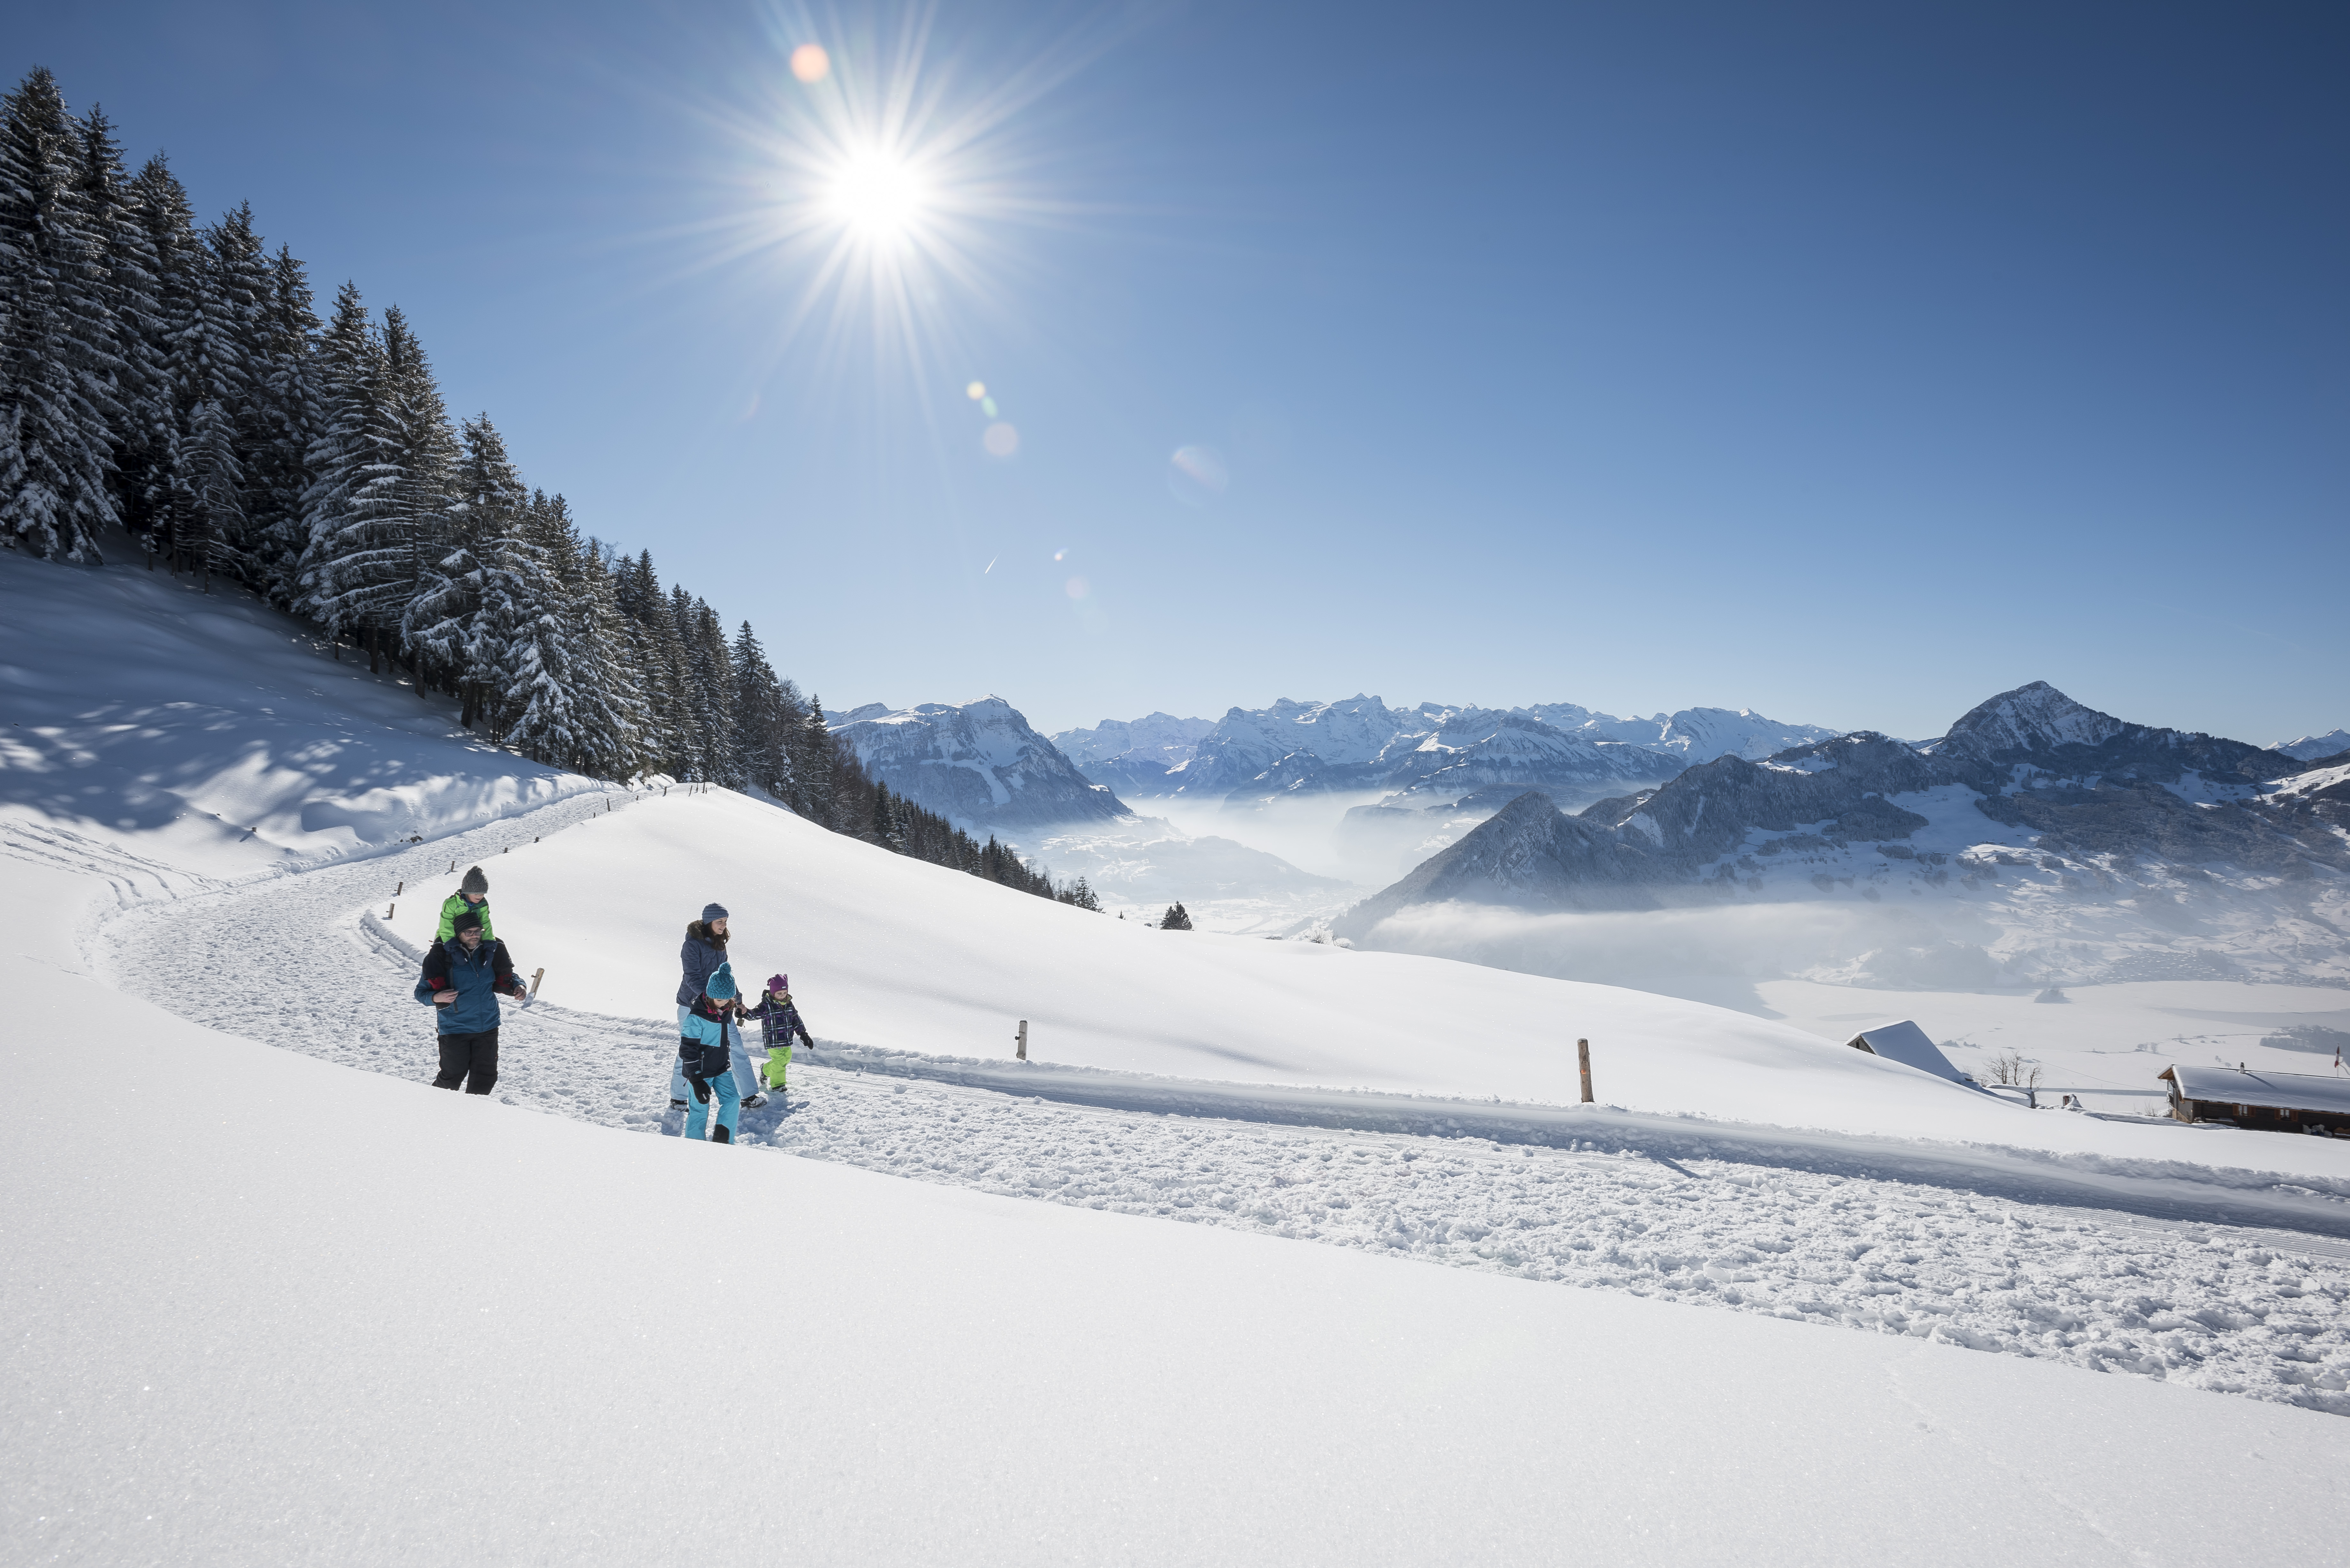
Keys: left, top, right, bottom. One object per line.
{"left": 83, "top": 792, "right": 2350, "bottom": 1415}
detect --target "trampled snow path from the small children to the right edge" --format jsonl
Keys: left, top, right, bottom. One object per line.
{"left": 743, "top": 1063, "right": 2350, "bottom": 1415}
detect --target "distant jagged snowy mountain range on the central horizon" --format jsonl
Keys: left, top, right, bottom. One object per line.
{"left": 1055, "top": 693, "right": 1835, "bottom": 809}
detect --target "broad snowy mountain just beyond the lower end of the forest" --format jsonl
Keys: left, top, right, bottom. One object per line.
{"left": 832, "top": 696, "right": 1130, "bottom": 832}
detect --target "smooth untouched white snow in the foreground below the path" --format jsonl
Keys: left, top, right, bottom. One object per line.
{"left": 18, "top": 950, "right": 2350, "bottom": 1568}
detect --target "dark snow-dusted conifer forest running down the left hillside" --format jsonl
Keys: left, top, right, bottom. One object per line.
{"left": 0, "top": 68, "right": 1100, "bottom": 908}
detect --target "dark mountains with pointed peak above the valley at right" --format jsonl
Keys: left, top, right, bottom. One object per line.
{"left": 1337, "top": 682, "right": 2350, "bottom": 983}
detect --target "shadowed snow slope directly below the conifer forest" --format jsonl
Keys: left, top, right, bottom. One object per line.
{"left": 0, "top": 550, "right": 599, "bottom": 877}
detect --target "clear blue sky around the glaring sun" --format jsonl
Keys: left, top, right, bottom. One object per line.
{"left": 14, "top": 0, "right": 2350, "bottom": 741}
